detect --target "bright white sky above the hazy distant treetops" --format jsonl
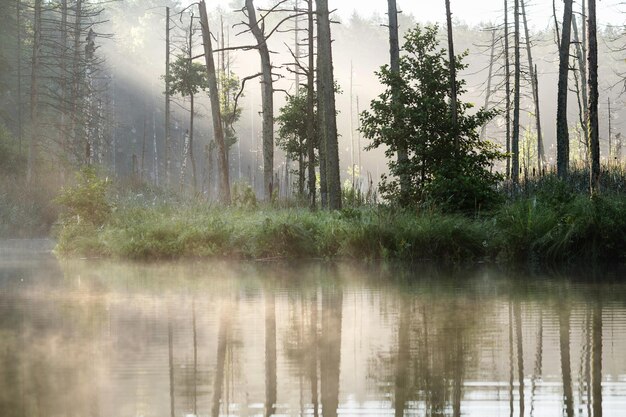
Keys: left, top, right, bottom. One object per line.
{"left": 208, "top": 0, "right": 626, "bottom": 28}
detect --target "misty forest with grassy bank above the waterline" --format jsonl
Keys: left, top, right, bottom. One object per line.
{"left": 0, "top": 0, "right": 626, "bottom": 261}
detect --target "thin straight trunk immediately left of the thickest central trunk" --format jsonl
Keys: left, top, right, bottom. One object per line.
{"left": 306, "top": 0, "right": 317, "bottom": 209}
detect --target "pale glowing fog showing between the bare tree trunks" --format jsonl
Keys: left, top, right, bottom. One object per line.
{"left": 85, "top": 1, "right": 626, "bottom": 192}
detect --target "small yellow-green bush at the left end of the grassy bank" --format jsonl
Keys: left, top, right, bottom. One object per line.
{"left": 56, "top": 167, "right": 112, "bottom": 226}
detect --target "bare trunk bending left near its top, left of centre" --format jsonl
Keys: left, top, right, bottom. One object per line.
{"left": 246, "top": 0, "right": 274, "bottom": 201}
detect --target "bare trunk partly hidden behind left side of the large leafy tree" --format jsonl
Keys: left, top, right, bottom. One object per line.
{"left": 388, "top": 0, "right": 408, "bottom": 205}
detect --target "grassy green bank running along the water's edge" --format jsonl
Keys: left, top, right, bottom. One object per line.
{"left": 56, "top": 193, "right": 626, "bottom": 262}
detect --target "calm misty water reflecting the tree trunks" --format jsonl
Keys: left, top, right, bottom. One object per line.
{"left": 0, "top": 241, "right": 626, "bottom": 417}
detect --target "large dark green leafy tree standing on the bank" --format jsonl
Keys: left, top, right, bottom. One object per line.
{"left": 361, "top": 25, "right": 504, "bottom": 211}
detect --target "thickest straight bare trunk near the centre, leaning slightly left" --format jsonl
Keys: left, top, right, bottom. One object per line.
{"left": 317, "top": 0, "right": 341, "bottom": 210}
